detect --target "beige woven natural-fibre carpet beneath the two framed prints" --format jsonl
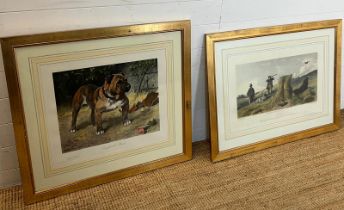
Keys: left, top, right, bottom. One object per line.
{"left": 0, "top": 115, "right": 344, "bottom": 209}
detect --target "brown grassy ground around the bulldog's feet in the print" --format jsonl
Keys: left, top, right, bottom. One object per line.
{"left": 58, "top": 93, "right": 160, "bottom": 152}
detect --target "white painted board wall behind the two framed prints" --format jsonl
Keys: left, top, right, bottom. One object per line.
{"left": 0, "top": 0, "right": 344, "bottom": 187}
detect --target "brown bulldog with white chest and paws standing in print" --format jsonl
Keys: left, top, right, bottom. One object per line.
{"left": 70, "top": 74, "right": 131, "bottom": 135}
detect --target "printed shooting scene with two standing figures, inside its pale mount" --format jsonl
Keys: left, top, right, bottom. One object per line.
{"left": 236, "top": 53, "right": 318, "bottom": 118}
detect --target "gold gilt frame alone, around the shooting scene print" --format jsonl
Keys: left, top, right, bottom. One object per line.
{"left": 206, "top": 20, "right": 342, "bottom": 162}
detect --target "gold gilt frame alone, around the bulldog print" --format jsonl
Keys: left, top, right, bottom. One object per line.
{"left": 1, "top": 20, "right": 192, "bottom": 204}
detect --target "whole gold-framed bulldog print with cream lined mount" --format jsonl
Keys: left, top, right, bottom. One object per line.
{"left": 1, "top": 21, "right": 192, "bottom": 204}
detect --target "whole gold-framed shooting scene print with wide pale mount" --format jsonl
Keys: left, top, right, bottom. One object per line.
{"left": 206, "top": 20, "right": 342, "bottom": 161}
